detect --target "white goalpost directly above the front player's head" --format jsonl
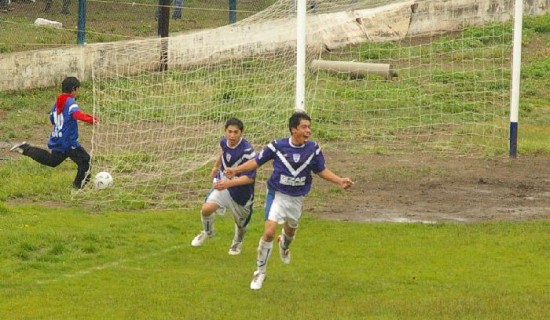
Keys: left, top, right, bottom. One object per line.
{"left": 295, "top": 0, "right": 307, "bottom": 111}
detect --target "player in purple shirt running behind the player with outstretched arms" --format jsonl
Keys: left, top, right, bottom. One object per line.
{"left": 191, "top": 118, "right": 256, "bottom": 255}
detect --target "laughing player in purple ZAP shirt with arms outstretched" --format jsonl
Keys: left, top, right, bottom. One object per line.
{"left": 225, "top": 112, "right": 353, "bottom": 290}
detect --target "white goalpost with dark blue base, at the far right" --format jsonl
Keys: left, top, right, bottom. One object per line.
{"left": 509, "top": 0, "right": 523, "bottom": 158}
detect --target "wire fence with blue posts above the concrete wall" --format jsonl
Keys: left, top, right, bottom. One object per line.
{"left": 0, "top": 0, "right": 277, "bottom": 53}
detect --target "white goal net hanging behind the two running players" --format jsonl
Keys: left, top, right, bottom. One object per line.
{"left": 83, "top": 0, "right": 513, "bottom": 208}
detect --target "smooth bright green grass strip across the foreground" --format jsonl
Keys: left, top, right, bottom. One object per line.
{"left": 0, "top": 205, "right": 550, "bottom": 319}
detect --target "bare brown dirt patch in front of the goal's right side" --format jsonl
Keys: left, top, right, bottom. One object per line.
{"left": 306, "top": 153, "right": 550, "bottom": 223}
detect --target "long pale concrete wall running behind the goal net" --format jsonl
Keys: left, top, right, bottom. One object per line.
{"left": 0, "top": 0, "right": 550, "bottom": 91}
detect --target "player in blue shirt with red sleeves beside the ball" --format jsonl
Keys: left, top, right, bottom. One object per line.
{"left": 10, "top": 77, "right": 99, "bottom": 189}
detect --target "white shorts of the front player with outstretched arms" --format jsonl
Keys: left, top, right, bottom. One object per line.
{"left": 264, "top": 188, "right": 304, "bottom": 229}
